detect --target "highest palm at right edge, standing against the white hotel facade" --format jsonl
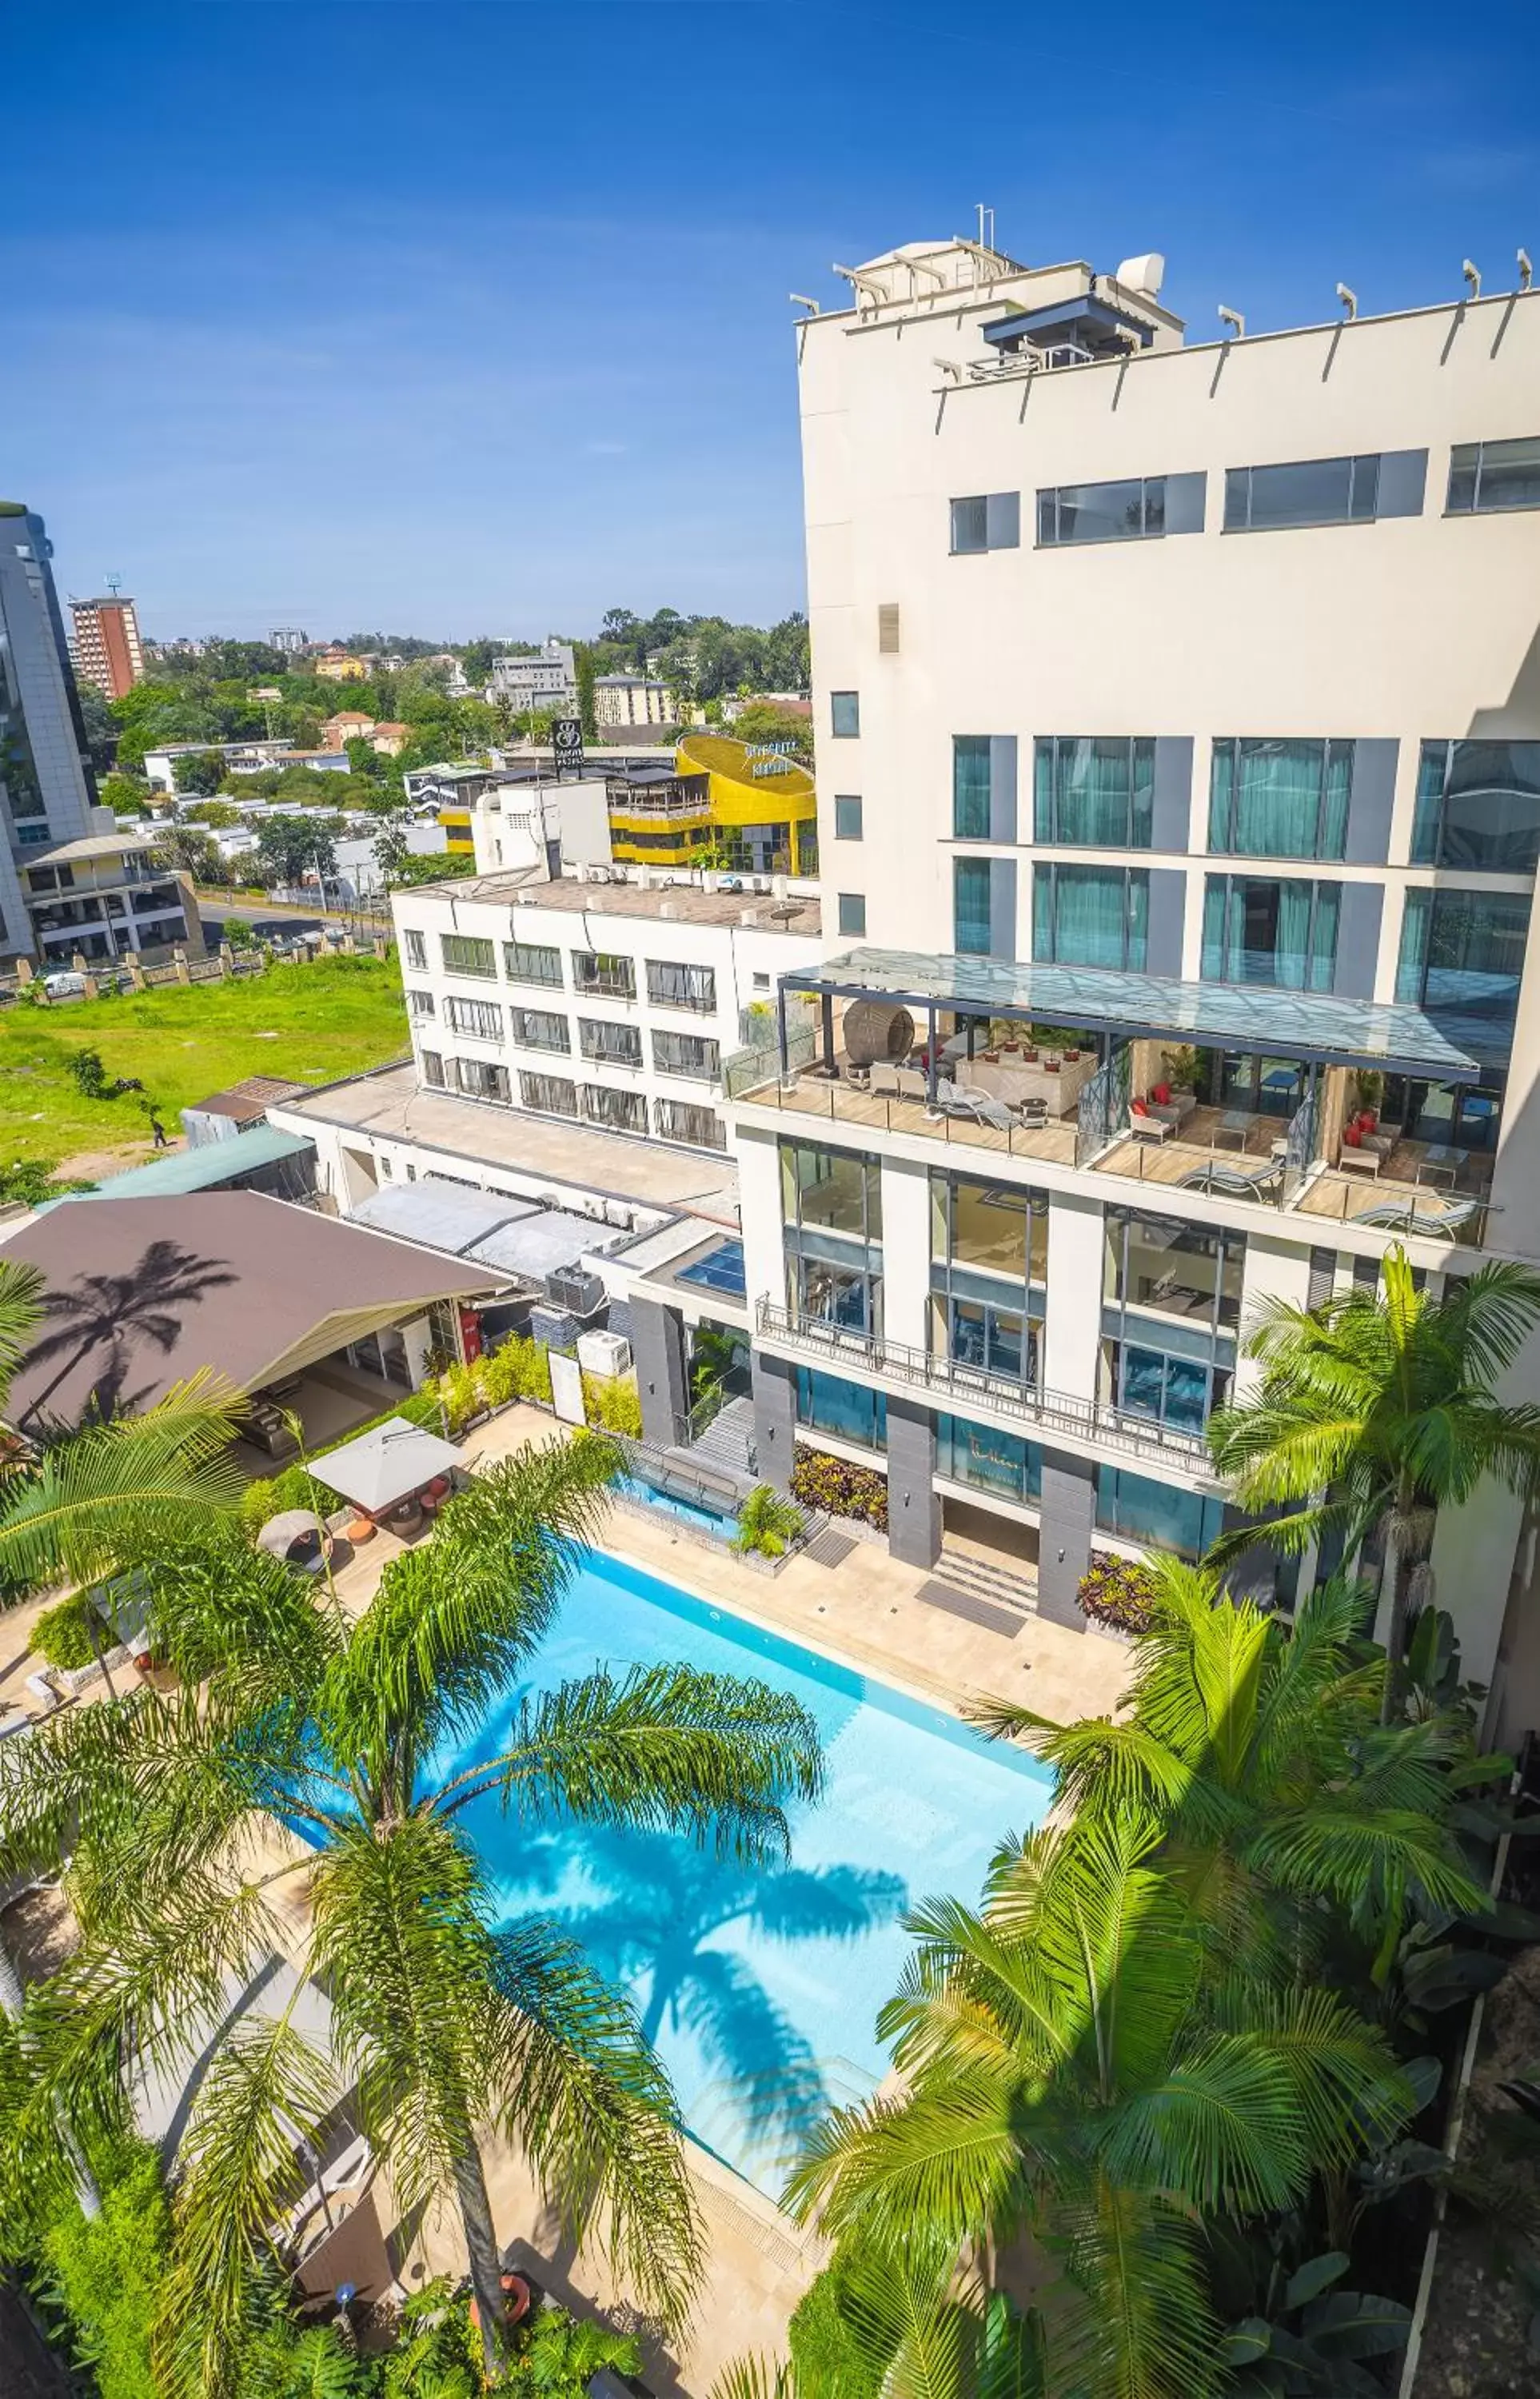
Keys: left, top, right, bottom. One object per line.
{"left": 1209, "top": 1247, "right": 1540, "bottom": 1722}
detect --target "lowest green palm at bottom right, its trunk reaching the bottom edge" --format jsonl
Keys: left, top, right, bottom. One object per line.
{"left": 792, "top": 1806, "right": 1413, "bottom": 2399}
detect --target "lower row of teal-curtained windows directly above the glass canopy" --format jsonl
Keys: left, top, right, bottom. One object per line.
{"left": 940, "top": 859, "right": 1530, "bottom": 1020}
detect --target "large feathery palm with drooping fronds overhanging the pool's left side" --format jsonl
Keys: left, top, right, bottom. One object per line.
{"left": 0, "top": 1439, "right": 820, "bottom": 2392}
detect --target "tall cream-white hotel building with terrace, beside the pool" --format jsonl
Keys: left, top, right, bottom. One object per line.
{"left": 732, "top": 229, "right": 1540, "bottom": 1720}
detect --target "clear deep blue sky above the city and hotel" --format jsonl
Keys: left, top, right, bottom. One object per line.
{"left": 0, "top": 0, "right": 1540, "bottom": 638}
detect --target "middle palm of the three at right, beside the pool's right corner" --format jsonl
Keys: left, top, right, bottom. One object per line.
{"left": 971, "top": 1557, "right": 1487, "bottom": 1977}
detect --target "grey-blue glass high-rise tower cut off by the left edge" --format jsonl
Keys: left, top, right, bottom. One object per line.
{"left": 0, "top": 501, "right": 96, "bottom": 957}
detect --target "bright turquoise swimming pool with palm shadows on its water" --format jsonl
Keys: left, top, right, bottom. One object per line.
{"left": 437, "top": 1555, "right": 1053, "bottom": 2197}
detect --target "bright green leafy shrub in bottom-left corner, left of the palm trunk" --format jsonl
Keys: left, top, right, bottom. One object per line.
{"left": 41, "top": 2142, "right": 170, "bottom": 2399}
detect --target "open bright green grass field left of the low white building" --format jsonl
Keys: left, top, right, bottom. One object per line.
{"left": 0, "top": 955, "right": 410, "bottom": 1178}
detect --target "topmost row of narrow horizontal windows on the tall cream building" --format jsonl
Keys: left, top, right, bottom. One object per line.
{"left": 950, "top": 437, "right": 1540, "bottom": 557}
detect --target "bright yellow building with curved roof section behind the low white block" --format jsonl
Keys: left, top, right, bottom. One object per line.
{"left": 609, "top": 734, "right": 818, "bottom": 876}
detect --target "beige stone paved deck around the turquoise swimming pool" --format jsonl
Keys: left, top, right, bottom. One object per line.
{"left": 0, "top": 1408, "right": 1130, "bottom": 2399}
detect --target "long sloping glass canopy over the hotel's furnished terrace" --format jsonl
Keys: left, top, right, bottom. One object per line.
{"left": 780, "top": 950, "right": 1511, "bottom": 1082}
